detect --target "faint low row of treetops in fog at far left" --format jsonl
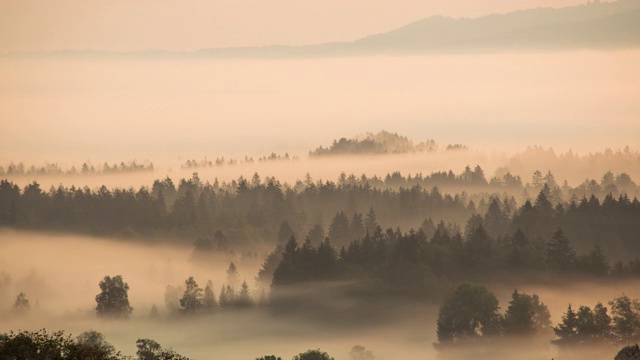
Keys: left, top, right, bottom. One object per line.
{"left": 0, "top": 160, "right": 154, "bottom": 176}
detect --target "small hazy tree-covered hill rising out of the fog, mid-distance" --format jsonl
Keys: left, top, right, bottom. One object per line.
{"left": 309, "top": 130, "right": 438, "bottom": 157}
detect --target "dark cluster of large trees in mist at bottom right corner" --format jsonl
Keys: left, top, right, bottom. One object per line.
{"left": 437, "top": 283, "right": 640, "bottom": 359}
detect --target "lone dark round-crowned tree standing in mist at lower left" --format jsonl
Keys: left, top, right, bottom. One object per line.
{"left": 96, "top": 275, "right": 133, "bottom": 319}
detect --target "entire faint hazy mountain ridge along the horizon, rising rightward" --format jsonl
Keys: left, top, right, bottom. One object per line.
{"left": 5, "top": 0, "right": 640, "bottom": 58}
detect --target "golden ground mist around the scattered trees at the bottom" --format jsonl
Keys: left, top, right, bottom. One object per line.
{"left": 0, "top": 230, "right": 640, "bottom": 360}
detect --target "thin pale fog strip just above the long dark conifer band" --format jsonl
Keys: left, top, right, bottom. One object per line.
{"left": 0, "top": 148, "right": 640, "bottom": 191}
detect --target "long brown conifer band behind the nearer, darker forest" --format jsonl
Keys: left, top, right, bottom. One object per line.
{"left": 0, "top": 167, "right": 639, "bottom": 253}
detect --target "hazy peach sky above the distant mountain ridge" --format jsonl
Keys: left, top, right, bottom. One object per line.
{"left": 0, "top": 0, "right": 585, "bottom": 52}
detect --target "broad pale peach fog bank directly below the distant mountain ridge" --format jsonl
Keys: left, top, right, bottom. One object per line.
{"left": 0, "top": 50, "right": 640, "bottom": 164}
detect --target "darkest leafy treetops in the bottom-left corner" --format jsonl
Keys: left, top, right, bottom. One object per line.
{"left": 0, "top": 329, "right": 189, "bottom": 360}
